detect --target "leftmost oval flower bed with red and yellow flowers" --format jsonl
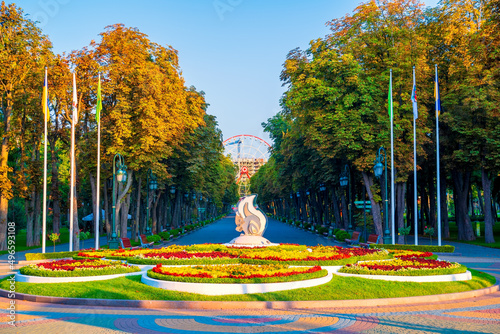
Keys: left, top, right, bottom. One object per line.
{"left": 19, "top": 259, "right": 140, "bottom": 277}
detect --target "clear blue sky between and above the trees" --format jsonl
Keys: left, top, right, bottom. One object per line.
{"left": 12, "top": 0, "right": 437, "bottom": 144}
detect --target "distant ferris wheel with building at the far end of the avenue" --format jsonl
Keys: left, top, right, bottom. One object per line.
{"left": 223, "top": 135, "right": 271, "bottom": 196}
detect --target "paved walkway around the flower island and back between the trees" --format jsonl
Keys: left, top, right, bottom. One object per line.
{"left": 0, "top": 218, "right": 500, "bottom": 334}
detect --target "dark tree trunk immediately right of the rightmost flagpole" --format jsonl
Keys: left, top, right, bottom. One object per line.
{"left": 451, "top": 169, "right": 476, "bottom": 241}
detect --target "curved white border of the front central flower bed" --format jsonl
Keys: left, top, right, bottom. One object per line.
{"left": 141, "top": 271, "right": 333, "bottom": 296}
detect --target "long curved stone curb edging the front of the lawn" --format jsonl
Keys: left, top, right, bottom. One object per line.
{"left": 0, "top": 282, "right": 500, "bottom": 310}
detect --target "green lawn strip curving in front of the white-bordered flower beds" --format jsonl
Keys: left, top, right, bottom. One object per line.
{"left": 0, "top": 269, "right": 495, "bottom": 301}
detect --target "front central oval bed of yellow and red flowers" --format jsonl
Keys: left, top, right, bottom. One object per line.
{"left": 147, "top": 264, "right": 328, "bottom": 284}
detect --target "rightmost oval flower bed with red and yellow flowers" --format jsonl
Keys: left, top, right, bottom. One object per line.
{"left": 339, "top": 257, "right": 467, "bottom": 276}
